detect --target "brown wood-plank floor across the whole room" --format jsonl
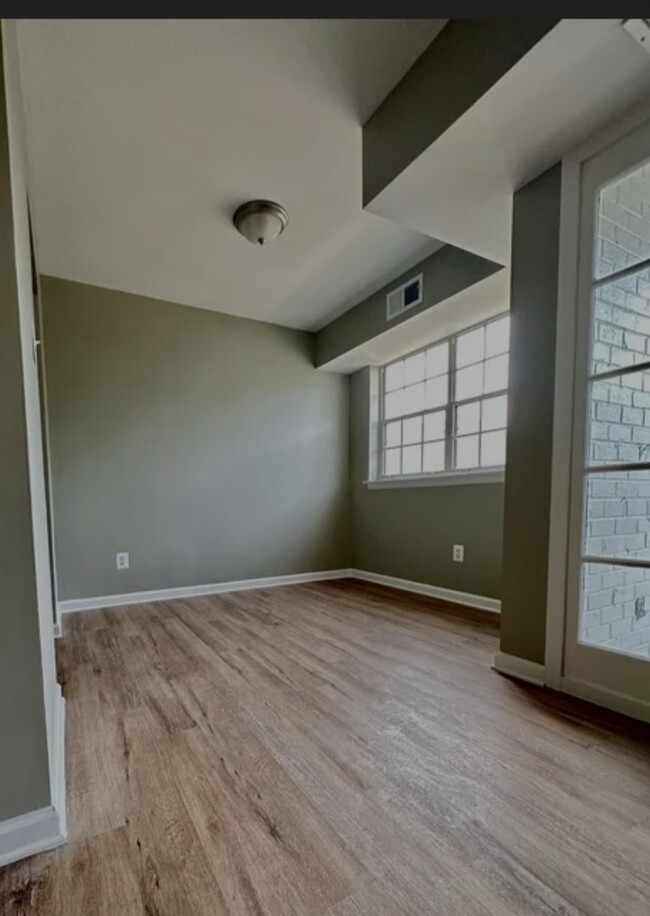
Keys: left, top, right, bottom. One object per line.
{"left": 0, "top": 582, "right": 650, "bottom": 916}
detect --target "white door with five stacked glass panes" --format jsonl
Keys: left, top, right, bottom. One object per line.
{"left": 563, "top": 118, "right": 650, "bottom": 702}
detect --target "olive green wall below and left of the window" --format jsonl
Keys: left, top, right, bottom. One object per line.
{"left": 350, "top": 369, "right": 503, "bottom": 598}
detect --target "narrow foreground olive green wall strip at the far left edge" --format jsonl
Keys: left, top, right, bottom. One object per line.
{"left": 0, "top": 24, "right": 54, "bottom": 821}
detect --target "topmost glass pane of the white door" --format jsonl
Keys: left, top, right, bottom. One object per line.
{"left": 594, "top": 165, "right": 650, "bottom": 277}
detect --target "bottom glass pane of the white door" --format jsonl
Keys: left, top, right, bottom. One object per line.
{"left": 578, "top": 563, "right": 650, "bottom": 658}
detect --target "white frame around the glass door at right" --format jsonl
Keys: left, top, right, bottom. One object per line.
{"left": 545, "top": 96, "right": 650, "bottom": 721}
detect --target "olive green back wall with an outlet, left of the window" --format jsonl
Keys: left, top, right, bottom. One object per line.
{"left": 42, "top": 277, "right": 350, "bottom": 600}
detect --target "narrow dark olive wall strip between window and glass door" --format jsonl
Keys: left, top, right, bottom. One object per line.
{"left": 501, "top": 164, "right": 561, "bottom": 664}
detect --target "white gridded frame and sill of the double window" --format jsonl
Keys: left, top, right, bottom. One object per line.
{"left": 366, "top": 310, "right": 510, "bottom": 489}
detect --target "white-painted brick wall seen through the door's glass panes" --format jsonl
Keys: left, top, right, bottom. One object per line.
{"left": 580, "top": 166, "right": 650, "bottom": 657}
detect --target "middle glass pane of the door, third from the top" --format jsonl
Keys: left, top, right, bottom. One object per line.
{"left": 587, "top": 371, "right": 650, "bottom": 465}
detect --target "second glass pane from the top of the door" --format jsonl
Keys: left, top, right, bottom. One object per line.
{"left": 590, "top": 268, "right": 650, "bottom": 374}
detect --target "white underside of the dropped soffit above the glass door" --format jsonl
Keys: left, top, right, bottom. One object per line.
{"left": 371, "top": 19, "right": 650, "bottom": 264}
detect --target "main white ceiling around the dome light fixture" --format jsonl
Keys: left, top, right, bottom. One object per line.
{"left": 18, "top": 19, "right": 444, "bottom": 329}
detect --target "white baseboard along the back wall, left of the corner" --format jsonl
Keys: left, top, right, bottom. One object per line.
{"left": 57, "top": 569, "right": 352, "bottom": 614}
